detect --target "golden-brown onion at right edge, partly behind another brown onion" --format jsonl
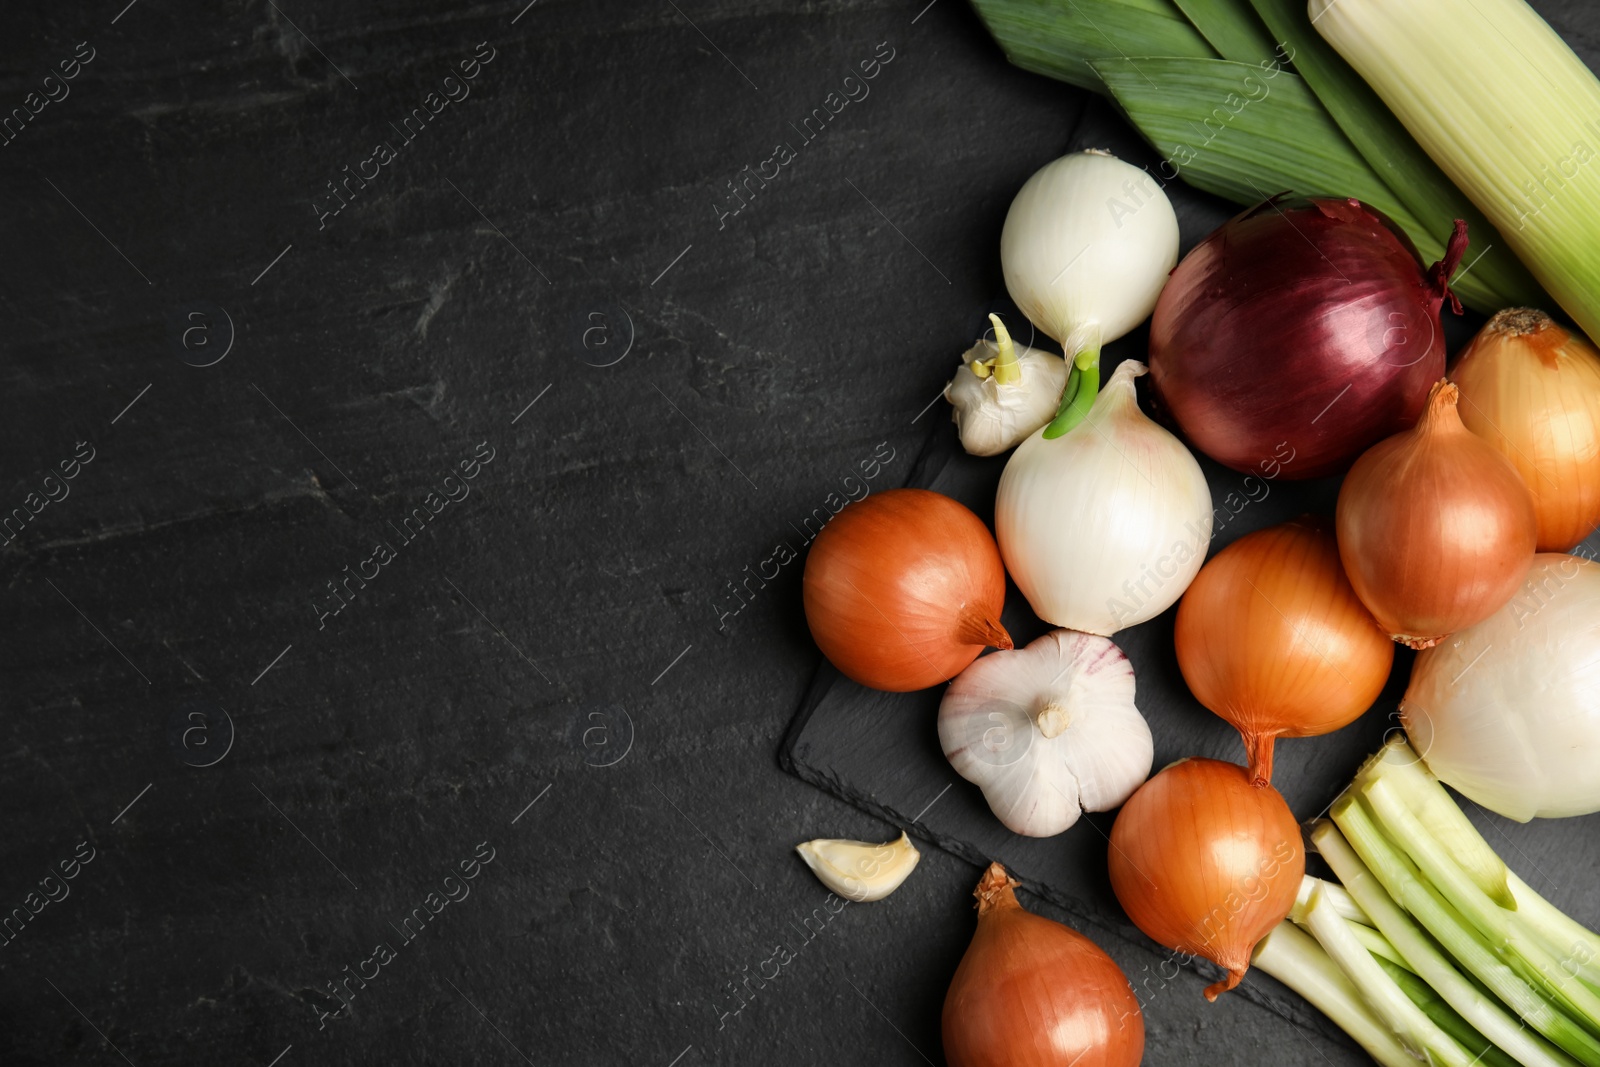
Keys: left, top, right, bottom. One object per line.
{"left": 1450, "top": 307, "right": 1600, "bottom": 552}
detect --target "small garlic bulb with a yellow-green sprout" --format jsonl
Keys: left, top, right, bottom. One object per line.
{"left": 944, "top": 315, "right": 1067, "bottom": 456}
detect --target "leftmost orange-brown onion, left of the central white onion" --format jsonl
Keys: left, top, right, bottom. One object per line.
{"left": 802, "top": 490, "right": 1011, "bottom": 693}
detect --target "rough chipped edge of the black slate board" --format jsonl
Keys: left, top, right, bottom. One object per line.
{"left": 778, "top": 422, "right": 1352, "bottom": 1045}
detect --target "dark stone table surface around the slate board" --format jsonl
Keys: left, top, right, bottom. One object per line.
{"left": 0, "top": 0, "right": 1590, "bottom": 1067}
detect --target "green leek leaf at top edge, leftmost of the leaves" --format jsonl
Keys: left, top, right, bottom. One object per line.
{"left": 973, "top": 0, "right": 1216, "bottom": 93}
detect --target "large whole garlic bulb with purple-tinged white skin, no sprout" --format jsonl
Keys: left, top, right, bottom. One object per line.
{"left": 939, "top": 630, "right": 1155, "bottom": 837}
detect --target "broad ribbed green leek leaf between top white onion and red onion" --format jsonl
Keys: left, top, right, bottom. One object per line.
{"left": 1091, "top": 56, "right": 1504, "bottom": 310}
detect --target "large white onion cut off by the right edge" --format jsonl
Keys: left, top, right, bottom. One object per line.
{"left": 1400, "top": 552, "right": 1600, "bottom": 822}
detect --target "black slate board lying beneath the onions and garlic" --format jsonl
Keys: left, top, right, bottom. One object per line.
{"left": 779, "top": 99, "right": 1600, "bottom": 1040}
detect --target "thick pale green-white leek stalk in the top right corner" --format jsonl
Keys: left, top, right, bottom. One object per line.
{"left": 1309, "top": 0, "right": 1600, "bottom": 338}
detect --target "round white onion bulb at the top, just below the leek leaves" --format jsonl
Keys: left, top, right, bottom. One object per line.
{"left": 1000, "top": 150, "right": 1178, "bottom": 366}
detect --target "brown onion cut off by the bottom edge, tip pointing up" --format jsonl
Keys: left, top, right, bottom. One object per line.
{"left": 941, "top": 864, "right": 1144, "bottom": 1067}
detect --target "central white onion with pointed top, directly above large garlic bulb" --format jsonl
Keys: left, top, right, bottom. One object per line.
{"left": 995, "top": 360, "right": 1211, "bottom": 637}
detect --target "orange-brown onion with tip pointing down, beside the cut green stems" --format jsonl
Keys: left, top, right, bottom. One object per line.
{"left": 1110, "top": 758, "right": 1306, "bottom": 1000}
